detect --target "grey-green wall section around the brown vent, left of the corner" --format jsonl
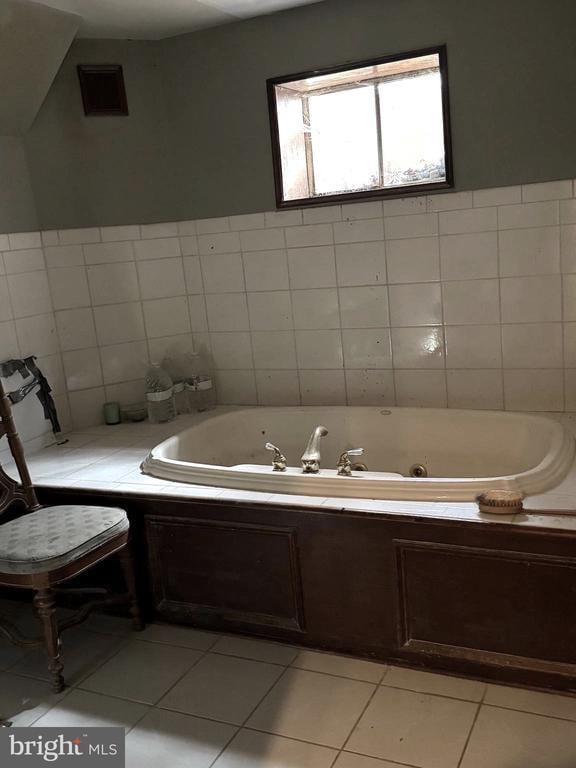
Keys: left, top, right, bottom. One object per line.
{"left": 25, "top": 40, "right": 177, "bottom": 229}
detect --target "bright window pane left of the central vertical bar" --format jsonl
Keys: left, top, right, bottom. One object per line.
{"left": 308, "top": 85, "right": 380, "bottom": 195}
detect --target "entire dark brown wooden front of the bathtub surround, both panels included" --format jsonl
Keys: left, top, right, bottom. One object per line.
{"left": 32, "top": 488, "right": 576, "bottom": 690}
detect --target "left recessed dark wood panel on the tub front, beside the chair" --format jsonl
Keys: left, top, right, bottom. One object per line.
{"left": 146, "top": 516, "right": 303, "bottom": 630}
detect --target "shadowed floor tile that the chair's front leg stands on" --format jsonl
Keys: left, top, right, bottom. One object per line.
{"left": 11, "top": 629, "right": 126, "bottom": 685}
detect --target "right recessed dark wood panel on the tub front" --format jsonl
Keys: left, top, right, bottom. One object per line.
{"left": 395, "top": 541, "right": 576, "bottom": 674}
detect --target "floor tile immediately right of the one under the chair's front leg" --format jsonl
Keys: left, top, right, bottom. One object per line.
{"left": 82, "top": 640, "right": 201, "bottom": 704}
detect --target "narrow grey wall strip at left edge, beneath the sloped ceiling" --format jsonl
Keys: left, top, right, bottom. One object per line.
{"left": 0, "top": 136, "right": 38, "bottom": 232}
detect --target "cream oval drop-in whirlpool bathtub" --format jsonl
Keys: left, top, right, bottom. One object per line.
{"left": 142, "top": 406, "right": 574, "bottom": 502}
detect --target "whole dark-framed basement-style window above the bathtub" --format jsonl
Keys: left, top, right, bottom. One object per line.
{"left": 268, "top": 47, "right": 452, "bottom": 207}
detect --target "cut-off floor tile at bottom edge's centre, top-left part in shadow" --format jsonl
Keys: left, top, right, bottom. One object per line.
{"left": 214, "top": 730, "right": 337, "bottom": 768}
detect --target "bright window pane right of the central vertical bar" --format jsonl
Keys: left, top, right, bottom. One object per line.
{"left": 378, "top": 71, "right": 446, "bottom": 187}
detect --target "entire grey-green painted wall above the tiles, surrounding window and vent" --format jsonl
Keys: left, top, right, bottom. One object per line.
{"left": 10, "top": 0, "right": 576, "bottom": 228}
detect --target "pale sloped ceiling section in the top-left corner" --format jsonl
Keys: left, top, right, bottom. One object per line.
{"left": 0, "top": 0, "right": 82, "bottom": 136}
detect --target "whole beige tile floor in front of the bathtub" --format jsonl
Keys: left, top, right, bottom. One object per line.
{"left": 0, "top": 601, "right": 576, "bottom": 768}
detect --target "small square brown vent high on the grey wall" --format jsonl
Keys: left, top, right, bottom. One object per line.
{"left": 78, "top": 64, "right": 128, "bottom": 115}
